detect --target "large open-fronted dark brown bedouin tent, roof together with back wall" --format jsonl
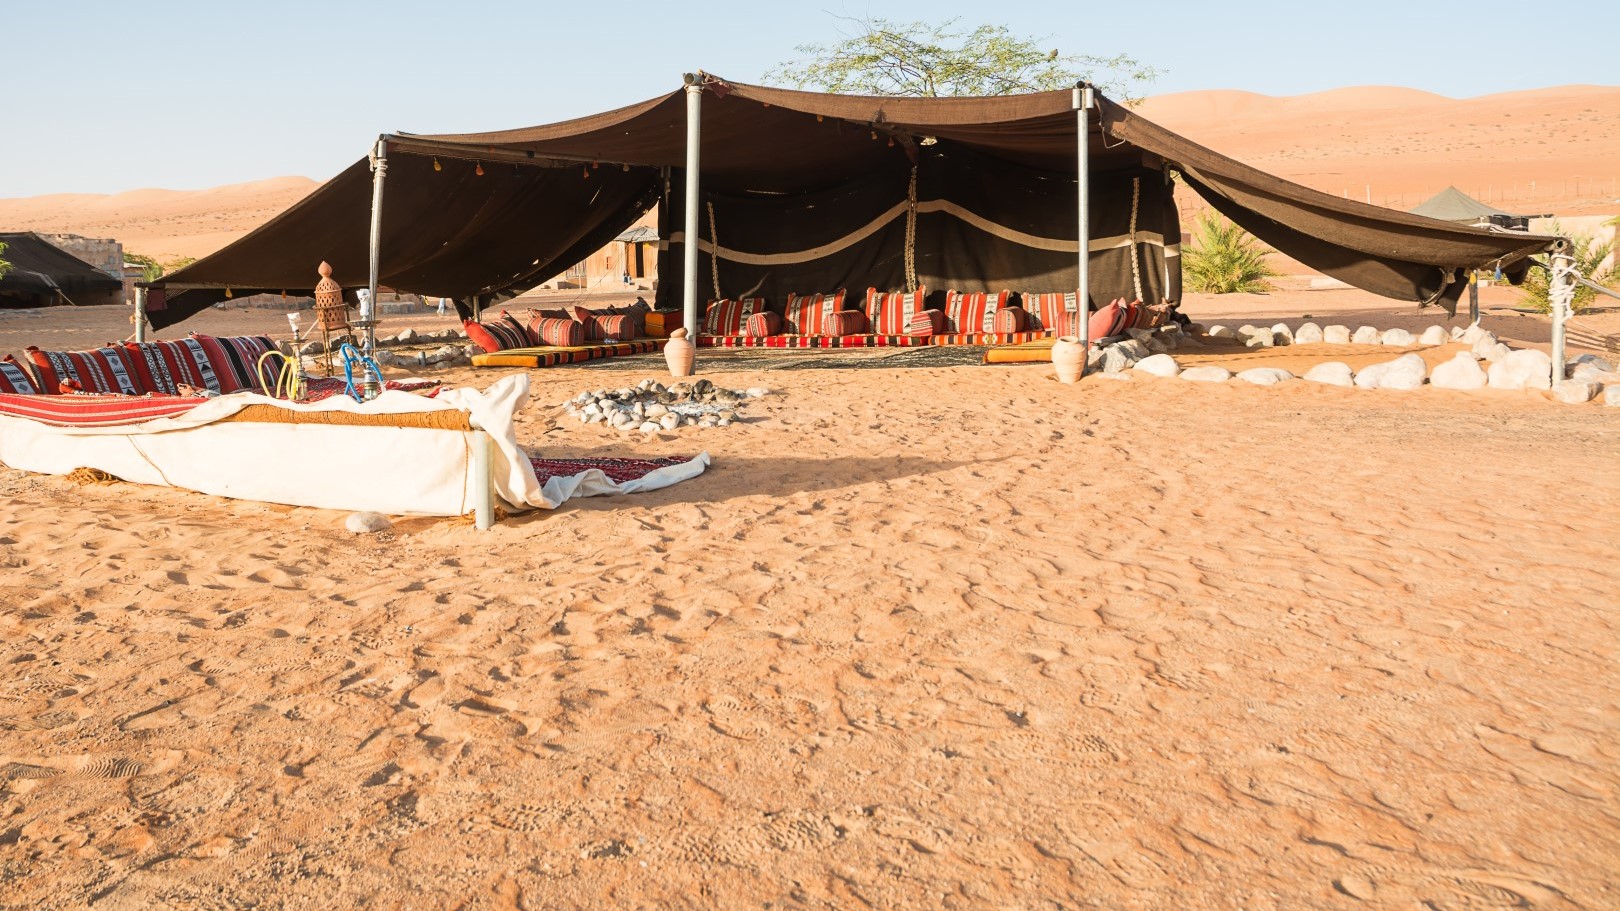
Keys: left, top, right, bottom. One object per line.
{"left": 147, "top": 73, "right": 1555, "bottom": 327}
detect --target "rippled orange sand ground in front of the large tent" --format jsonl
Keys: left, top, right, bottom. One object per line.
{"left": 0, "top": 295, "right": 1620, "bottom": 911}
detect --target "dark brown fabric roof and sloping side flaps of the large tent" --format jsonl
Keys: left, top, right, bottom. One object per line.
{"left": 152, "top": 76, "right": 1555, "bottom": 326}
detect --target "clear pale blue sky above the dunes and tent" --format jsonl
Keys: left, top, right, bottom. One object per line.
{"left": 0, "top": 0, "right": 1620, "bottom": 198}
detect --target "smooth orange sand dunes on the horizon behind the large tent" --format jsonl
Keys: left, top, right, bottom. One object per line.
{"left": 0, "top": 86, "right": 1620, "bottom": 259}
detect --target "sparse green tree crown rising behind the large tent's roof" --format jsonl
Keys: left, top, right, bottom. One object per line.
{"left": 765, "top": 16, "right": 1160, "bottom": 104}
